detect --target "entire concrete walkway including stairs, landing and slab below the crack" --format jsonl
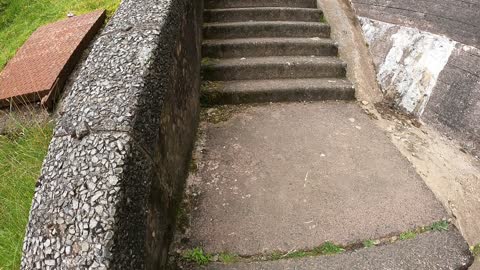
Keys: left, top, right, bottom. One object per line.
{"left": 174, "top": 0, "right": 472, "bottom": 269}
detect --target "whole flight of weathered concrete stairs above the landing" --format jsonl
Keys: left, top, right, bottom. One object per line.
{"left": 202, "top": 0, "right": 355, "bottom": 104}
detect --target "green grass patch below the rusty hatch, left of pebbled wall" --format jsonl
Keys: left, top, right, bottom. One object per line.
{"left": 0, "top": 113, "right": 53, "bottom": 270}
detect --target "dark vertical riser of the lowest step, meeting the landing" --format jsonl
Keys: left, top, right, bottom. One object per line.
{"left": 201, "top": 88, "right": 355, "bottom": 106}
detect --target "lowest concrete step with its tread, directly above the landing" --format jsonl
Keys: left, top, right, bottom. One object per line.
{"left": 201, "top": 78, "right": 355, "bottom": 105}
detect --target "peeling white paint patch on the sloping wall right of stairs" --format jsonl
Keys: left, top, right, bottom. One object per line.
{"left": 359, "top": 17, "right": 456, "bottom": 116}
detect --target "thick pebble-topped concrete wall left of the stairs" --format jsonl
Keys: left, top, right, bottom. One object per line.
{"left": 22, "top": 0, "right": 202, "bottom": 269}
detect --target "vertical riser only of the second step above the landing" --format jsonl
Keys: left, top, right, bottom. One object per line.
{"left": 203, "top": 64, "right": 346, "bottom": 81}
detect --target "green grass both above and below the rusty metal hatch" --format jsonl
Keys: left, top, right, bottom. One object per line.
{"left": 0, "top": 0, "right": 121, "bottom": 270}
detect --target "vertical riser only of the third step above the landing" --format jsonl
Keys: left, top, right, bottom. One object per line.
{"left": 202, "top": 43, "right": 338, "bottom": 58}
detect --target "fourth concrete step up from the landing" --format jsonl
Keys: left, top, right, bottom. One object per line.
{"left": 203, "top": 21, "right": 330, "bottom": 39}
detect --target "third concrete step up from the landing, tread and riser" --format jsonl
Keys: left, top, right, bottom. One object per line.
{"left": 202, "top": 38, "right": 338, "bottom": 58}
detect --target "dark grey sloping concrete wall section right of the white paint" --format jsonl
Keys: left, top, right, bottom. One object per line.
{"left": 423, "top": 44, "right": 480, "bottom": 156}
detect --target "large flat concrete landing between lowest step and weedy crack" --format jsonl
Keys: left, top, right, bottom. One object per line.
{"left": 190, "top": 102, "right": 447, "bottom": 255}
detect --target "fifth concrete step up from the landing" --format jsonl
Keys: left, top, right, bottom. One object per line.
{"left": 204, "top": 7, "right": 322, "bottom": 22}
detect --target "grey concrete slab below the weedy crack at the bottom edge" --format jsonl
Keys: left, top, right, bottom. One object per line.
{"left": 202, "top": 231, "right": 472, "bottom": 270}
